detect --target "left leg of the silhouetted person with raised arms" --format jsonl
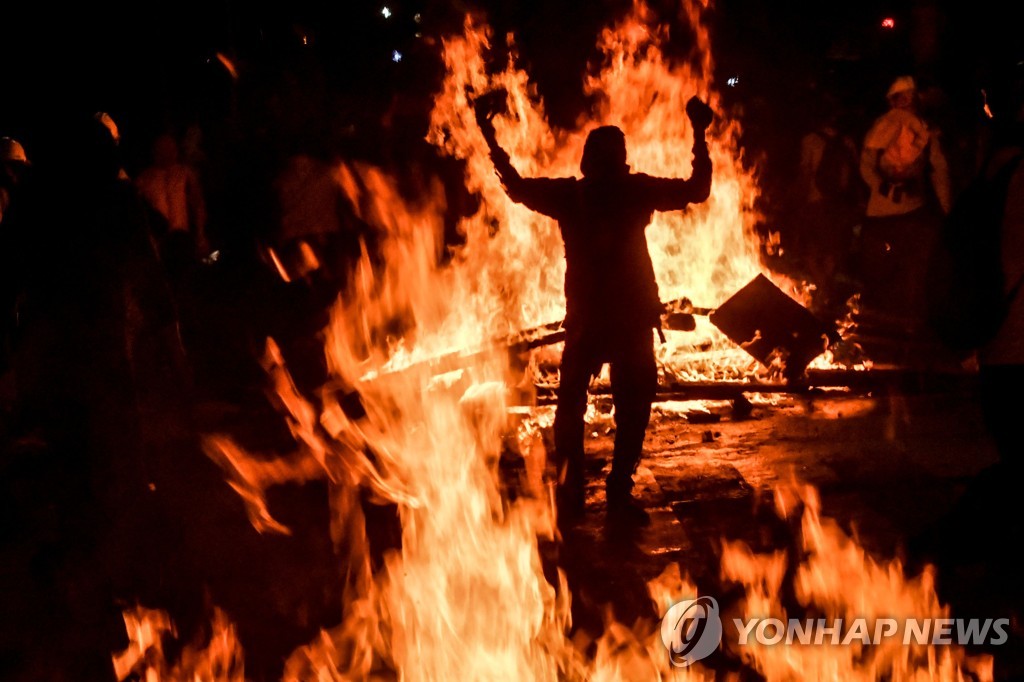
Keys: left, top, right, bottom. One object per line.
{"left": 554, "top": 330, "right": 594, "bottom": 512}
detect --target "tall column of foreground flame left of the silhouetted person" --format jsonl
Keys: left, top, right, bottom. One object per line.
{"left": 319, "top": 160, "right": 567, "bottom": 680}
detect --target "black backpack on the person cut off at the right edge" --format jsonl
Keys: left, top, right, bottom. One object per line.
{"left": 927, "top": 154, "right": 1024, "bottom": 352}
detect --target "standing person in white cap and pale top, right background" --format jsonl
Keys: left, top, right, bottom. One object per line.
{"left": 860, "top": 76, "right": 952, "bottom": 325}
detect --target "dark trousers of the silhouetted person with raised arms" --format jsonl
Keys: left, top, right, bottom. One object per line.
{"left": 555, "top": 327, "right": 657, "bottom": 497}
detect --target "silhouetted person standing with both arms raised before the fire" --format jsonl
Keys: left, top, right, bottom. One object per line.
{"left": 476, "top": 95, "right": 714, "bottom": 524}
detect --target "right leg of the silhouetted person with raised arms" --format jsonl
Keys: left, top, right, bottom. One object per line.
{"left": 607, "top": 329, "right": 657, "bottom": 503}
